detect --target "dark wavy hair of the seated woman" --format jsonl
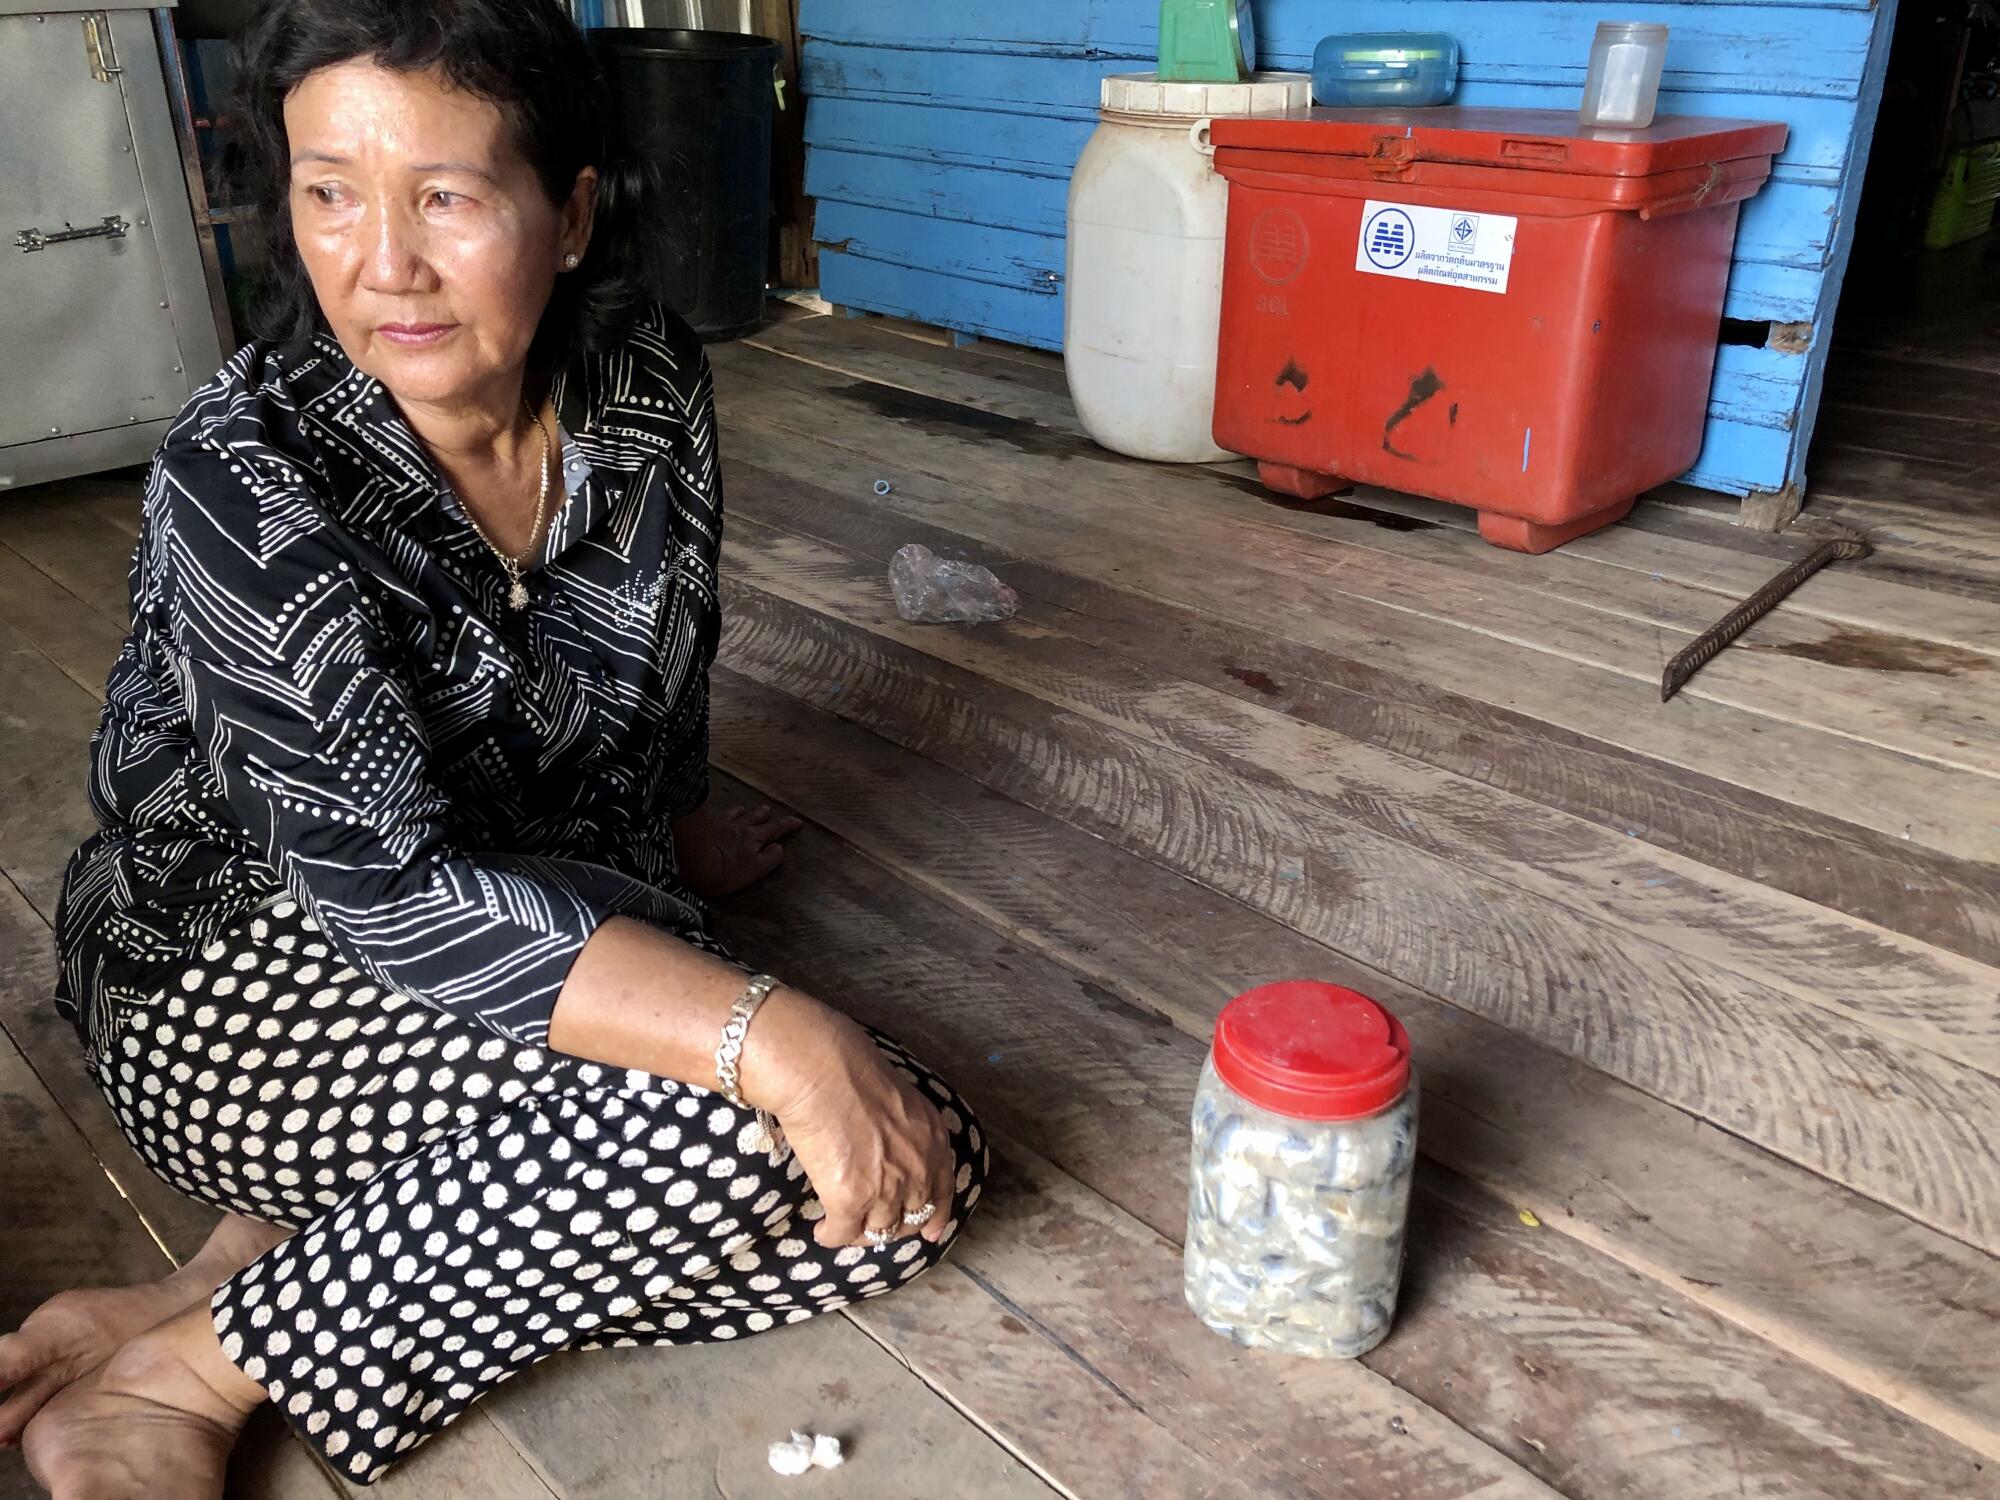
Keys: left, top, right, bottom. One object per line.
{"left": 226, "top": 0, "right": 658, "bottom": 370}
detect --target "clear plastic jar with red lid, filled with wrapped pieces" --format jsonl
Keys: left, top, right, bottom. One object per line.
{"left": 1186, "top": 980, "right": 1418, "bottom": 1360}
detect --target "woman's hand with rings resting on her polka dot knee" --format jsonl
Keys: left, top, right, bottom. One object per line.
{"left": 750, "top": 1010, "right": 958, "bottom": 1250}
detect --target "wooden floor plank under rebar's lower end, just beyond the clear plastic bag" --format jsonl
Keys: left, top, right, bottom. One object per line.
{"left": 720, "top": 354, "right": 2000, "bottom": 856}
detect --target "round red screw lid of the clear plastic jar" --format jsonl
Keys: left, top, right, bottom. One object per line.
{"left": 1216, "top": 980, "right": 1410, "bottom": 1120}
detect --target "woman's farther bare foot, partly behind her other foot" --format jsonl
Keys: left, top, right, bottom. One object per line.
{"left": 0, "top": 1214, "right": 292, "bottom": 1448}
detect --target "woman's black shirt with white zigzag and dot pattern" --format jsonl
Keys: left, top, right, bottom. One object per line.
{"left": 58, "top": 310, "right": 722, "bottom": 1044}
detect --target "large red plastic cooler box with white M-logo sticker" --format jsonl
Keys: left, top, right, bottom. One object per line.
{"left": 1214, "top": 108, "right": 1784, "bottom": 552}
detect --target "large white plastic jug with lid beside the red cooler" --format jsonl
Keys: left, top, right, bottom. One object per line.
{"left": 1062, "top": 72, "right": 1312, "bottom": 464}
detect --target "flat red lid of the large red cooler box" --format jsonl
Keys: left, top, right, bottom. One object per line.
{"left": 1214, "top": 104, "right": 1786, "bottom": 178}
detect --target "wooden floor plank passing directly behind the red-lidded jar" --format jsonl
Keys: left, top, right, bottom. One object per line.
{"left": 714, "top": 670, "right": 2000, "bottom": 1454}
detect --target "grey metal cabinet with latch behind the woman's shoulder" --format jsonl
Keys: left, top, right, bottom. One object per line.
{"left": 0, "top": 0, "right": 222, "bottom": 490}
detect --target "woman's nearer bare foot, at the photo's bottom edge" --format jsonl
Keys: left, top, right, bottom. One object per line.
{"left": 20, "top": 1304, "right": 264, "bottom": 1500}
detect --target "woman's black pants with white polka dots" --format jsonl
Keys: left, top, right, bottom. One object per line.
{"left": 92, "top": 902, "right": 986, "bottom": 1484}
